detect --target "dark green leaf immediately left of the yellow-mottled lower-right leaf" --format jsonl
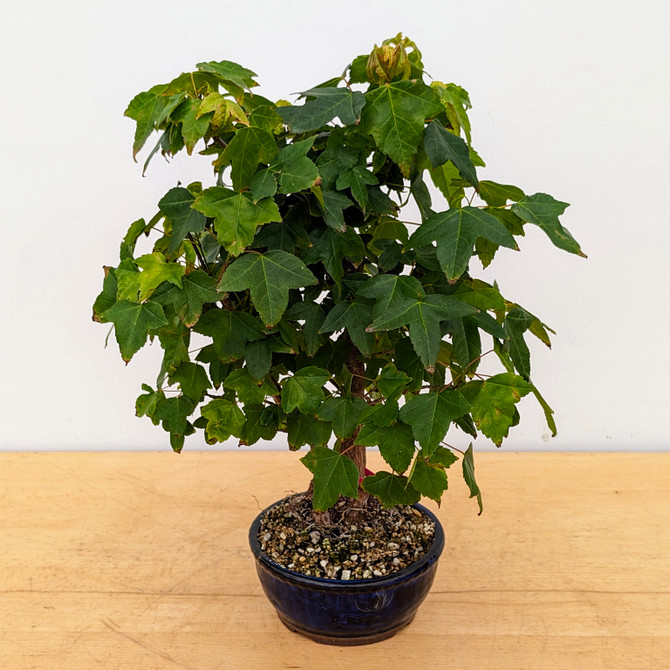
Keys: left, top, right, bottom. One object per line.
{"left": 400, "top": 389, "right": 470, "bottom": 456}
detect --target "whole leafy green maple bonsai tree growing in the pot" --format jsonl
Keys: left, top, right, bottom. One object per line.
{"left": 93, "top": 35, "right": 583, "bottom": 513}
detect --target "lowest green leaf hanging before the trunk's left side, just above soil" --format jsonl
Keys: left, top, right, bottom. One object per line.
{"left": 300, "top": 447, "right": 358, "bottom": 511}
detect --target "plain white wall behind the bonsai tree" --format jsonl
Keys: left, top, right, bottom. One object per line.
{"left": 0, "top": 0, "right": 670, "bottom": 450}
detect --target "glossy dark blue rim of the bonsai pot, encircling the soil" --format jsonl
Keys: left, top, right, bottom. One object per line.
{"left": 249, "top": 496, "right": 444, "bottom": 589}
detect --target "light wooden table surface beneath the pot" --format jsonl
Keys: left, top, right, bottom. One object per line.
{"left": 0, "top": 450, "right": 670, "bottom": 670}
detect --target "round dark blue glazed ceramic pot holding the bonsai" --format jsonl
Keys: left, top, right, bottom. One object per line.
{"left": 249, "top": 503, "right": 444, "bottom": 645}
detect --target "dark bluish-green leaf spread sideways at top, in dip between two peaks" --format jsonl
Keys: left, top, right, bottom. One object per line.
{"left": 277, "top": 87, "right": 365, "bottom": 134}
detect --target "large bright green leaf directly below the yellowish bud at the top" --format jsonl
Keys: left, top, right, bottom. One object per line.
{"left": 361, "top": 80, "right": 442, "bottom": 177}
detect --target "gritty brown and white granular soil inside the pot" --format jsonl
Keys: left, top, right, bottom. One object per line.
{"left": 258, "top": 493, "right": 435, "bottom": 580}
